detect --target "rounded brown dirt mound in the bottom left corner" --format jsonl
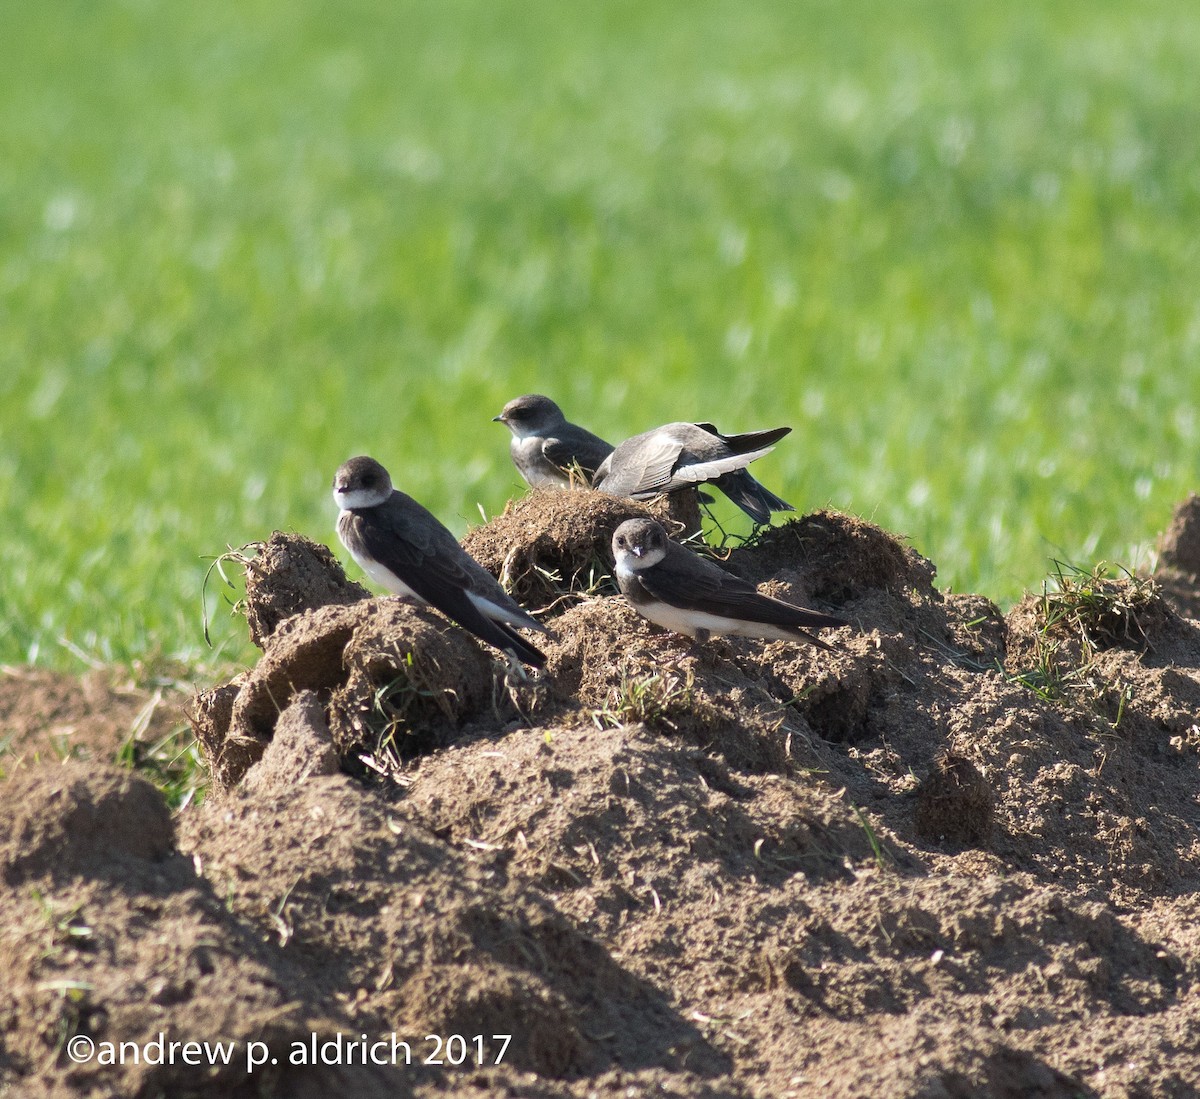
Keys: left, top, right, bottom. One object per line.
{"left": 0, "top": 763, "right": 384, "bottom": 1097}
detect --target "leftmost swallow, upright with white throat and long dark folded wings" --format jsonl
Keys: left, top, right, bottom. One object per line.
{"left": 334, "top": 457, "right": 546, "bottom": 668}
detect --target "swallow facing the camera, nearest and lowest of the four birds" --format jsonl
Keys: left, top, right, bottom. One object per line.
{"left": 612, "top": 520, "right": 850, "bottom": 650}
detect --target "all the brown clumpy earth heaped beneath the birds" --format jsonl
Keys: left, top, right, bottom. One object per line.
{"left": 0, "top": 493, "right": 1200, "bottom": 1099}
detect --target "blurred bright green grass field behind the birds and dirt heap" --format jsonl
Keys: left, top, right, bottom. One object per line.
{"left": 0, "top": 0, "right": 1200, "bottom": 667}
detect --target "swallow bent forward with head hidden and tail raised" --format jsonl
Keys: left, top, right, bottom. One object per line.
{"left": 592, "top": 422, "right": 794, "bottom": 523}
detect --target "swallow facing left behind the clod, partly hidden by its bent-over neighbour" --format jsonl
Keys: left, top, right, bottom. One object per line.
{"left": 492, "top": 394, "right": 612, "bottom": 488}
